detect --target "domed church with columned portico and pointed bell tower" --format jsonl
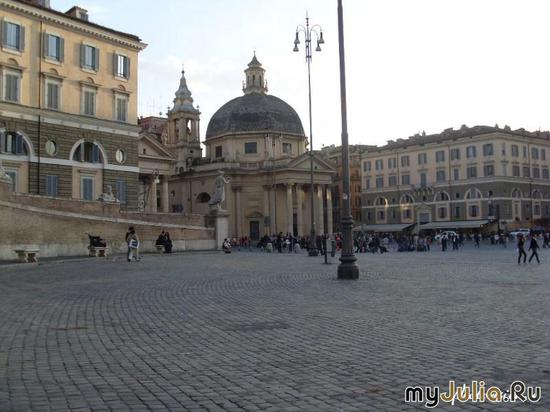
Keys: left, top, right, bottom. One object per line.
{"left": 142, "top": 55, "right": 336, "bottom": 240}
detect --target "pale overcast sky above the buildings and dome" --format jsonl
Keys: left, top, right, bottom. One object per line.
{"left": 56, "top": 0, "right": 550, "bottom": 149}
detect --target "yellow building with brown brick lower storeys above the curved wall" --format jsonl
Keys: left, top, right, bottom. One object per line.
{"left": 0, "top": 0, "right": 146, "bottom": 208}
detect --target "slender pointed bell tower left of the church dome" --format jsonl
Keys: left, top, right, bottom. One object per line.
{"left": 166, "top": 70, "right": 202, "bottom": 174}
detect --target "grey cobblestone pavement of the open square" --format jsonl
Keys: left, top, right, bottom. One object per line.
{"left": 0, "top": 246, "right": 550, "bottom": 411}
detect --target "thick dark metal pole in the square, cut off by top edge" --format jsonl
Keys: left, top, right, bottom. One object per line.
{"left": 338, "top": 0, "right": 359, "bottom": 279}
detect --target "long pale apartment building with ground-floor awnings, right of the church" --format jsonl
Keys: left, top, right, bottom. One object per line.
{"left": 361, "top": 126, "right": 550, "bottom": 232}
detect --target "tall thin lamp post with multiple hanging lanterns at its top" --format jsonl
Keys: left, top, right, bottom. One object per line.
{"left": 293, "top": 12, "right": 325, "bottom": 256}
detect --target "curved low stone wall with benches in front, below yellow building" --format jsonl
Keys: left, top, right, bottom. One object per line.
{"left": 0, "top": 184, "right": 216, "bottom": 260}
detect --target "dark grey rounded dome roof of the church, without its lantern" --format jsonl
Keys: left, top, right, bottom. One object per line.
{"left": 206, "top": 93, "right": 304, "bottom": 139}
